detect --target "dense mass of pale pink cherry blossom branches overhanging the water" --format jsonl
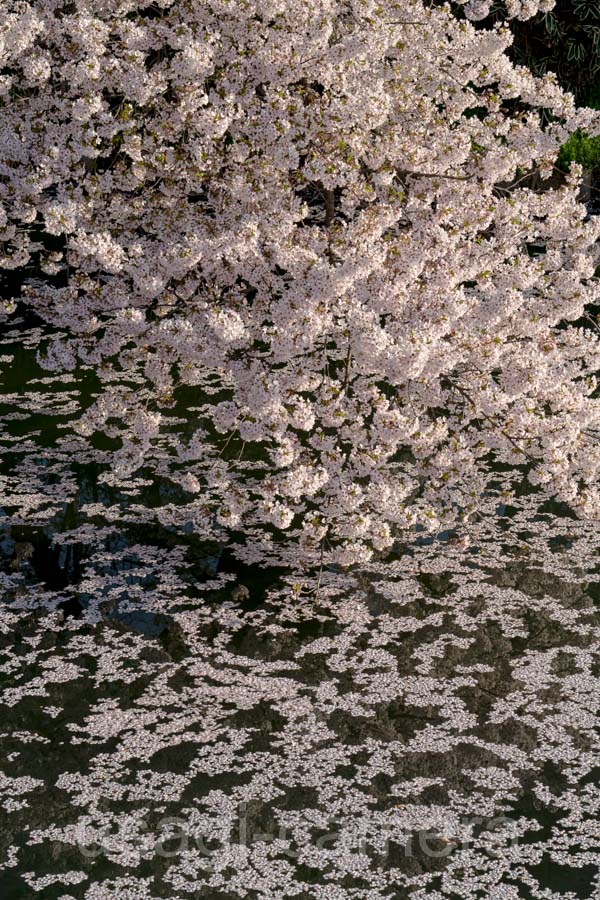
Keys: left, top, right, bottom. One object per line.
{"left": 0, "top": 0, "right": 600, "bottom": 565}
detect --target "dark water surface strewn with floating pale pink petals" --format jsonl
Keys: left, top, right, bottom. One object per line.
{"left": 0, "top": 320, "right": 600, "bottom": 900}
